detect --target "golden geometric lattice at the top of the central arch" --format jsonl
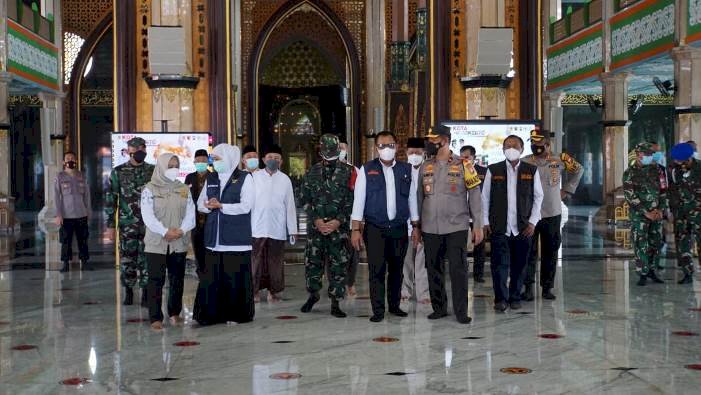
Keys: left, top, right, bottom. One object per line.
{"left": 260, "top": 41, "right": 345, "bottom": 88}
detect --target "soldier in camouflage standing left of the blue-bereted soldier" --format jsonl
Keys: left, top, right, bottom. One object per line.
{"left": 623, "top": 143, "right": 667, "bottom": 286}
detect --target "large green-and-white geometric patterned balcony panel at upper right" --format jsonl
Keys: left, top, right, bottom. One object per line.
{"left": 610, "top": 0, "right": 675, "bottom": 69}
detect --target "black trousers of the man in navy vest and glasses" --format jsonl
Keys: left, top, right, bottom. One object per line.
{"left": 363, "top": 223, "right": 409, "bottom": 315}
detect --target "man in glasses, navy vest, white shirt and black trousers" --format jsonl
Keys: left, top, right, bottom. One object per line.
{"left": 351, "top": 131, "right": 419, "bottom": 322}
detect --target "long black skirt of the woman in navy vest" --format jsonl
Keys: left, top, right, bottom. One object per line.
{"left": 193, "top": 250, "right": 255, "bottom": 325}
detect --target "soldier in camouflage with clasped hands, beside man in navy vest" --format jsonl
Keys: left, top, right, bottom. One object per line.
{"left": 301, "top": 134, "right": 355, "bottom": 318}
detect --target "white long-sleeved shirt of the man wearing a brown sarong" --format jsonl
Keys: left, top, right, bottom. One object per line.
{"left": 251, "top": 170, "right": 297, "bottom": 240}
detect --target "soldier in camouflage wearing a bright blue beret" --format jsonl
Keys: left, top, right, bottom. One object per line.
{"left": 669, "top": 143, "right": 701, "bottom": 284}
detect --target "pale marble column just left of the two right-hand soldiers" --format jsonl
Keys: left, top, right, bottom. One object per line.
{"left": 599, "top": 72, "right": 630, "bottom": 196}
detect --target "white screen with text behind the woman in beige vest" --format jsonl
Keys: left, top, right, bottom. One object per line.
{"left": 112, "top": 132, "right": 209, "bottom": 181}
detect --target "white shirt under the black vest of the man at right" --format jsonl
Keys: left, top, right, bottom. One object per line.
{"left": 482, "top": 161, "right": 543, "bottom": 236}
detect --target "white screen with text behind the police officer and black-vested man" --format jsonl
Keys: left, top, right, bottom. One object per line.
{"left": 444, "top": 121, "right": 538, "bottom": 166}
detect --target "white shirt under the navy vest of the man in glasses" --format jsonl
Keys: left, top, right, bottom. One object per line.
{"left": 351, "top": 161, "right": 419, "bottom": 221}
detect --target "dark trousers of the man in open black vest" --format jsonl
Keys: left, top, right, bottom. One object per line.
{"left": 490, "top": 233, "right": 531, "bottom": 303}
